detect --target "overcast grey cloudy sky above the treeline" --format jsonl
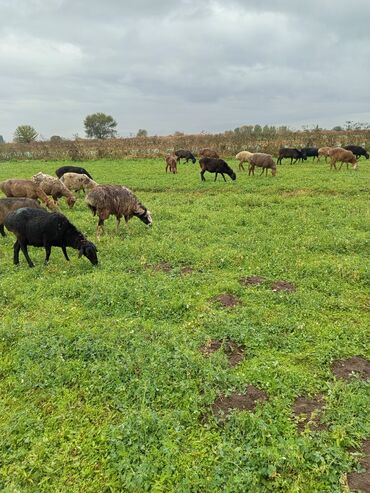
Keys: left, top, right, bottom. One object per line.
{"left": 0, "top": 0, "right": 370, "bottom": 141}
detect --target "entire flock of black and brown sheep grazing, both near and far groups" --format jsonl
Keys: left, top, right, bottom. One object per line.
{"left": 0, "top": 140, "right": 369, "bottom": 267}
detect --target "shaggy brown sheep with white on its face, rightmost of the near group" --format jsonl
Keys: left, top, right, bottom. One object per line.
{"left": 85, "top": 185, "right": 152, "bottom": 237}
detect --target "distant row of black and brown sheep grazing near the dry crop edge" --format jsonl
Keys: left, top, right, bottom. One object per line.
{"left": 165, "top": 145, "right": 369, "bottom": 181}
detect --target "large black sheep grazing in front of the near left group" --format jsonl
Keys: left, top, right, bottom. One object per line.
{"left": 4, "top": 207, "right": 98, "bottom": 267}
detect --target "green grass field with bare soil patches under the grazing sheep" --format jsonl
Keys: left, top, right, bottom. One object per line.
{"left": 0, "top": 160, "right": 370, "bottom": 493}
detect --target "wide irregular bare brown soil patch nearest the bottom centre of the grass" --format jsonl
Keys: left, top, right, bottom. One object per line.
{"left": 212, "top": 385, "right": 267, "bottom": 418}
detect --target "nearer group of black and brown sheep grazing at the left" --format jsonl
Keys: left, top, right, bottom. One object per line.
{"left": 0, "top": 166, "right": 152, "bottom": 267}
